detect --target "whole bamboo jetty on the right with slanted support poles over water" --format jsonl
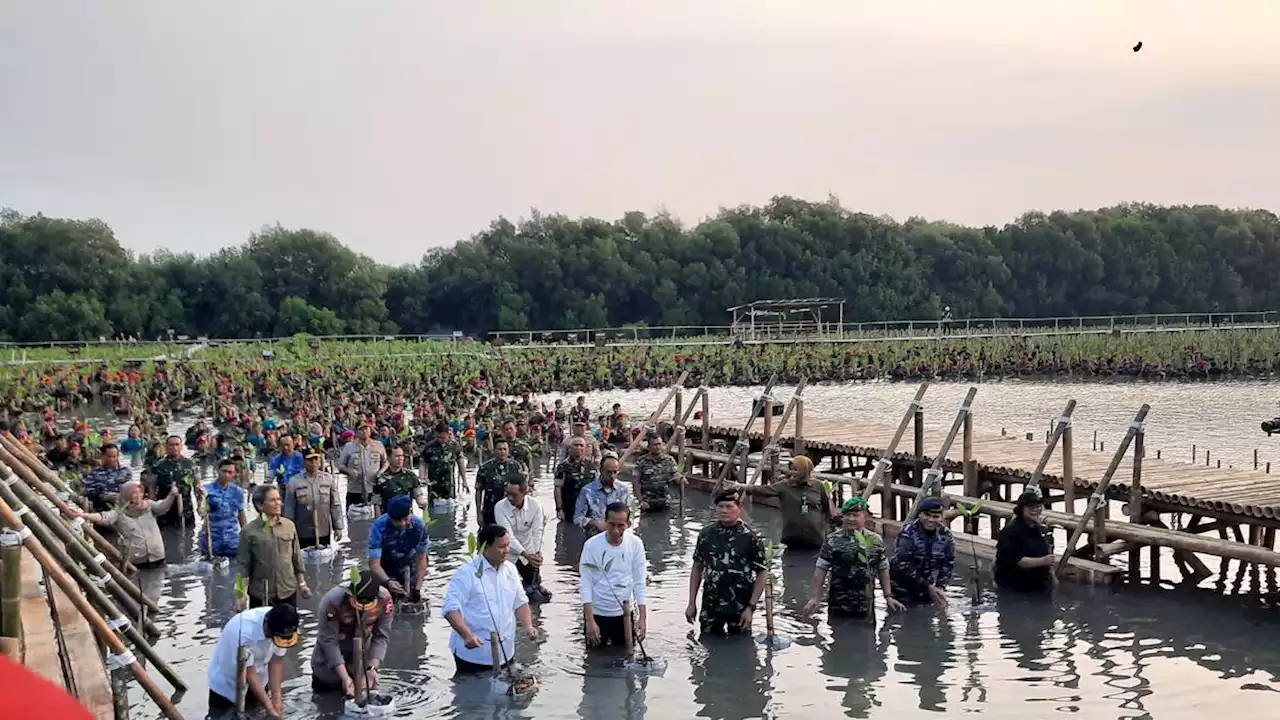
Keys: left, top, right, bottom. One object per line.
{"left": 659, "top": 380, "right": 1280, "bottom": 588}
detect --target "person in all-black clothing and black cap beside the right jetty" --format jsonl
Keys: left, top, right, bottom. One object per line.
{"left": 996, "top": 489, "right": 1057, "bottom": 593}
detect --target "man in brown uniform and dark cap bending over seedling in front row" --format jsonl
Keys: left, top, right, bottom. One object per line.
{"left": 311, "top": 570, "right": 396, "bottom": 697}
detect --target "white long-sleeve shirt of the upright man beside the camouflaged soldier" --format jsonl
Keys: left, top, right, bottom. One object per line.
{"left": 579, "top": 530, "right": 646, "bottom": 618}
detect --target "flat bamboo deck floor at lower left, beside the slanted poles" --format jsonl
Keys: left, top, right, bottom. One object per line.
{"left": 22, "top": 552, "right": 115, "bottom": 720}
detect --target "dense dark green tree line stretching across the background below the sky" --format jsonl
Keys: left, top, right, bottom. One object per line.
{"left": 0, "top": 197, "right": 1280, "bottom": 342}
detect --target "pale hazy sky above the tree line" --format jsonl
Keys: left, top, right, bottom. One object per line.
{"left": 0, "top": 0, "right": 1280, "bottom": 263}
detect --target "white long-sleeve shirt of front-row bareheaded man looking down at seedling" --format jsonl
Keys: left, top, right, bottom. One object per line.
{"left": 440, "top": 556, "right": 529, "bottom": 666}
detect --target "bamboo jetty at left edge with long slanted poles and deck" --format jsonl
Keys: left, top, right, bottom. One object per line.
{"left": 0, "top": 430, "right": 187, "bottom": 720}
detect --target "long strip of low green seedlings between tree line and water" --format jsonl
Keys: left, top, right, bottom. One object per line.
{"left": 0, "top": 328, "right": 1280, "bottom": 411}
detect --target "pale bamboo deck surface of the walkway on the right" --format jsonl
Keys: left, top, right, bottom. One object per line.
{"left": 706, "top": 413, "right": 1280, "bottom": 520}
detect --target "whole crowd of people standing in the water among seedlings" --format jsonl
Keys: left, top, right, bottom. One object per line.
{"left": 6, "top": 366, "right": 1053, "bottom": 716}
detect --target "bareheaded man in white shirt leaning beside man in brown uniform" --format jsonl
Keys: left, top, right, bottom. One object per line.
{"left": 440, "top": 525, "right": 538, "bottom": 674}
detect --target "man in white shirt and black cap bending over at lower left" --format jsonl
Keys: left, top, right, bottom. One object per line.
{"left": 209, "top": 602, "right": 298, "bottom": 717}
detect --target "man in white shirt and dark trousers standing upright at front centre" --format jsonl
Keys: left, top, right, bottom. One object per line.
{"left": 579, "top": 502, "right": 646, "bottom": 647}
